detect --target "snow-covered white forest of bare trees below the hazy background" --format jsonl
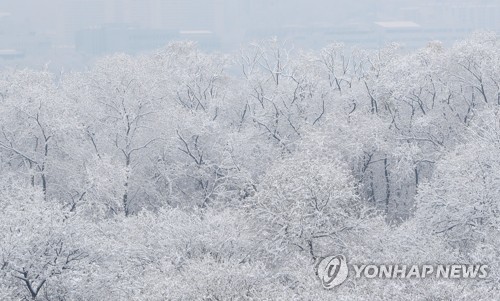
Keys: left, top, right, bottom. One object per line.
{"left": 0, "top": 33, "right": 500, "bottom": 301}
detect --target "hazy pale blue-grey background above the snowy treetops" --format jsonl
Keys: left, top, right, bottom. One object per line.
{"left": 0, "top": 0, "right": 500, "bottom": 68}
